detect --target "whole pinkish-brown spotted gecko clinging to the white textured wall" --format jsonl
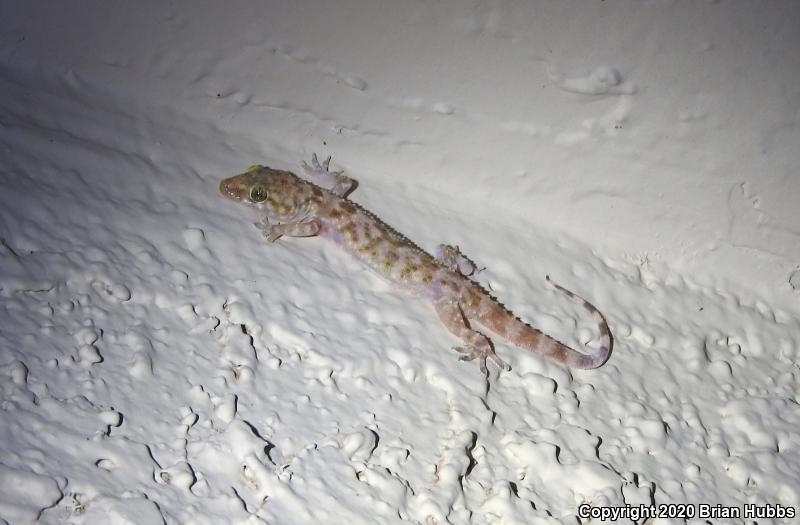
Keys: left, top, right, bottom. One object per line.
{"left": 219, "top": 154, "right": 613, "bottom": 374}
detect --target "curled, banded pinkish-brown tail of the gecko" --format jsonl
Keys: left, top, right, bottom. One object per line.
{"left": 476, "top": 276, "right": 613, "bottom": 369}
